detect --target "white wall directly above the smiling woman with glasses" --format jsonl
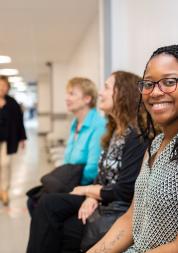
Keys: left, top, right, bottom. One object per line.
{"left": 111, "top": 0, "right": 178, "bottom": 74}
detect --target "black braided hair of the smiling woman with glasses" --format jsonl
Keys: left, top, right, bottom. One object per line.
{"left": 138, "top": 45, "right": 178, "bottom": 162}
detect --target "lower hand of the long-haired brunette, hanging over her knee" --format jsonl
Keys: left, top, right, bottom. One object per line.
{"left": 78, "top": 198, "right": 98, "bottom": 224}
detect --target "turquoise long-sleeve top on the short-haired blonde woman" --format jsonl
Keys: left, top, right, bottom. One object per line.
{"left": 64, "top": 108, "right": 105, "bottom": 185}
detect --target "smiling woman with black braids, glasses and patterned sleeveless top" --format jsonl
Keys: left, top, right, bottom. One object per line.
{"left": 87, "top": 45, "right": 178, "bottom": 253}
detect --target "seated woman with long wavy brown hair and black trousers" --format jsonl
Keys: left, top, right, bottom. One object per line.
{"left": 27, "top": 71, "right": 148, "bottom": 253}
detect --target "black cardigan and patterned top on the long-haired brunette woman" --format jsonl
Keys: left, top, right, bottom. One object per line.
{"left": 95, "top": 127, "right": 148, "bottom": 205}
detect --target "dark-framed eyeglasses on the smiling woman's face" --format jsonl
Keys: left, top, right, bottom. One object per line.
{"left": 138, "top": 78, "right": 178, "bottom": 95}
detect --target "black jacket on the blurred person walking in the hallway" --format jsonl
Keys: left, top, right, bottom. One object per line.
{"left": 5, "top": 96, "right": 27, "bottom": 154}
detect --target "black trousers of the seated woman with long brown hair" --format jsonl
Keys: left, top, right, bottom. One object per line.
{"left": 27, "top": 193, "right": 85, "bottom": 253}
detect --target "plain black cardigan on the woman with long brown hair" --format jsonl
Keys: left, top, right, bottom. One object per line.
{"left": 95, "top": 129, "right": 148, "bottom": 204}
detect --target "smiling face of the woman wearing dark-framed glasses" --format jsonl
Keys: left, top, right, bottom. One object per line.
{"left": 141, "top": 54, "right": 178, "bottom": 127}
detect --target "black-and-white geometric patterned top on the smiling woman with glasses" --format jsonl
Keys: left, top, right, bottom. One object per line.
{"left": 125, "top": 134, "right": 178, "bottom": 253}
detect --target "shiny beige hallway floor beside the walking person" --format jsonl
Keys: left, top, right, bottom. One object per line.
{"left": 0, "top": 119, "right": 54, "bottom": 253}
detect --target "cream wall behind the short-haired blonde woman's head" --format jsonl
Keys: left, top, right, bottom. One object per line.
{"left": 52, "top": 16, "right": 100, "bottom": 113}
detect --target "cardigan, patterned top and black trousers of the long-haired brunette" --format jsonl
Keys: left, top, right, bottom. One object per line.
{"left": 27, "top": 128, "right": 148, "bottom": 253}
